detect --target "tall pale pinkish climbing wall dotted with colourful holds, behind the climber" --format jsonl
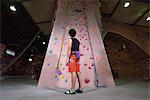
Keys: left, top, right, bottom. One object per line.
{"left": 38, "top": 0, "right": 114, "bottom": 89}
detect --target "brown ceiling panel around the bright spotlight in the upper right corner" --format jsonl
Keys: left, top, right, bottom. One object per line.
{"left": 111, "top": 1, "right": 149, "bottom": 24}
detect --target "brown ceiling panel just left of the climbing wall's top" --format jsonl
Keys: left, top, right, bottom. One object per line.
{"left": 22, "top": 0, "right": 55, "bottom": 23}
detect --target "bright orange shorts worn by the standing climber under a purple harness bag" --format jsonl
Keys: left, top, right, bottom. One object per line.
{"left": 68, "top": 54, "right": 80, "bottom": 72}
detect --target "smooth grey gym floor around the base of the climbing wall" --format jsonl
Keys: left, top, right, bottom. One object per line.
{"left": 0, "top": 78, "right": 149, "bottom": 100}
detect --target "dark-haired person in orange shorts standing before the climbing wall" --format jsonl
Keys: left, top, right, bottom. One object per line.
{"left": 65, "top": 29, "right": 83, "bottom": 94}
